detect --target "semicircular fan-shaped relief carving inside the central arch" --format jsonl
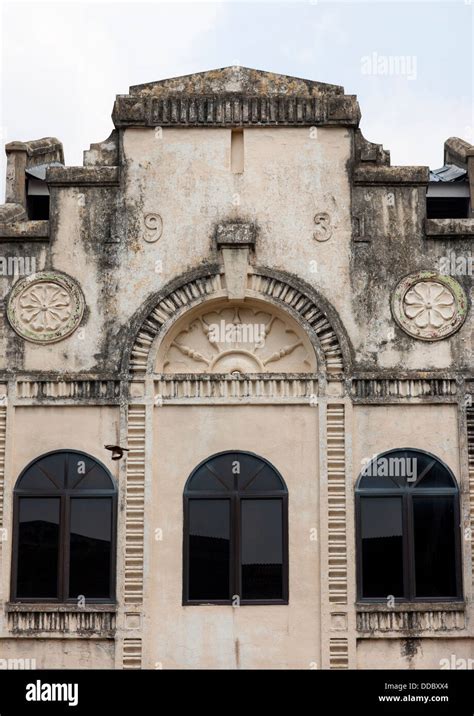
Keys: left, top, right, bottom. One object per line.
{"left": 156, "top": 302, "right": 316, "bottom": 373}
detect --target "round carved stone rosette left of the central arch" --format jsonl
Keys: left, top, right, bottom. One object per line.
{"left": 7, "top": 271, "right": 84, "bottom": 343}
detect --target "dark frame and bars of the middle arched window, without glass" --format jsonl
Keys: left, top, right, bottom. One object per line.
{"left": 182, "top": 450, "right": 289, "bottom": 606}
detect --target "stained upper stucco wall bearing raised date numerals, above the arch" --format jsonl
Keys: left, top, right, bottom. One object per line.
{"left": 0, "top": 121, "right": 473, "bottom": 371}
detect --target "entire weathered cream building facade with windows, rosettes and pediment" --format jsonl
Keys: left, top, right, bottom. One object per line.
{"left": 0, "top": 68, "right": 474, "bottom": 669}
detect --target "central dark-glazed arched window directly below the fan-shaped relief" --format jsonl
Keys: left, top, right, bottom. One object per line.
{"left": 183, "top": 452, "right": 288, "bottom": 604}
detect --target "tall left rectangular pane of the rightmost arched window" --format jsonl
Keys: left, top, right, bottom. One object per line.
{"left": 360, "top": 497, "right": 403, "bottom": 599}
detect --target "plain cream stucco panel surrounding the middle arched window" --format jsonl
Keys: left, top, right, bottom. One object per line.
{"left": 148, "top": 406, "right": 320, "bottom": 669}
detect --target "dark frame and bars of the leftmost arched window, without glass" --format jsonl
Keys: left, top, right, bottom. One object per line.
{"left": 10, "top": 448, "right": 118, "bottom": 604}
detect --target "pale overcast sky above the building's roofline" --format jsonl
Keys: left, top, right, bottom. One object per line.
{"left": 0, "top": 0, "right": 474, "bottom": 200}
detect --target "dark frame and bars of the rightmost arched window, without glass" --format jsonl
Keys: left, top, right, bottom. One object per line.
{"left": 355, "top": 447, "right": 464, "bottom": 604}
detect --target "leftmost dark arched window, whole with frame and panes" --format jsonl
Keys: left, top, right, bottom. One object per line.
{"left": 12, "top": 450, "right": 117, "bottom": 603}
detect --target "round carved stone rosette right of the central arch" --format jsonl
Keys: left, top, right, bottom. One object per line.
{"left": 392, "top": 271, "right": 467, "bottom": 341}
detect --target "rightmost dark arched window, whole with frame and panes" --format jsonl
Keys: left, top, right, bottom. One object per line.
{"left": 356, "top": 448, "right": 462, "bottom": 601}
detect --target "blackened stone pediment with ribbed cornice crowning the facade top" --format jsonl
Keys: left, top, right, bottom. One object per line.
{"left": 112, "top": 67, "right": 360, "bottom": 127}
